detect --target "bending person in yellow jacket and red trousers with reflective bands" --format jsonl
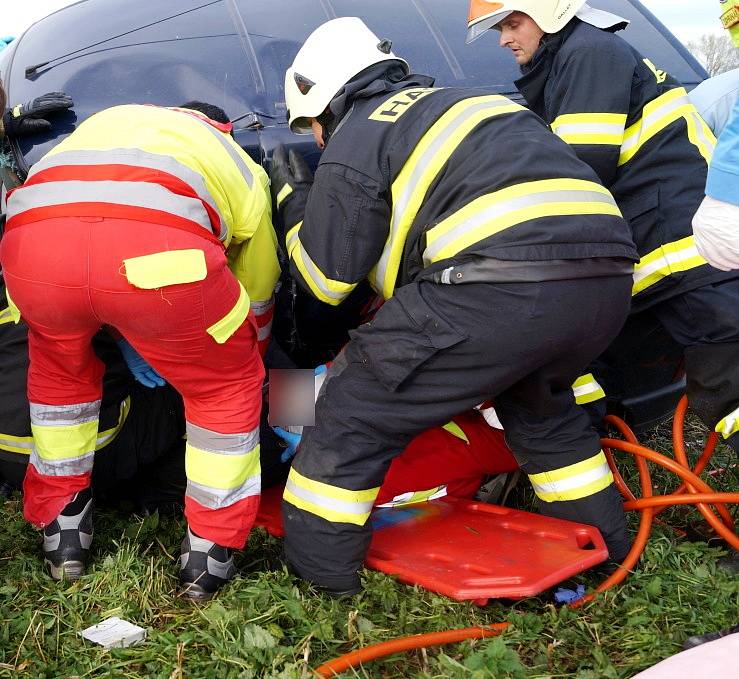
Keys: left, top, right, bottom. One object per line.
{"left": 0, "top": 102, "right": 279, "bottom": 598}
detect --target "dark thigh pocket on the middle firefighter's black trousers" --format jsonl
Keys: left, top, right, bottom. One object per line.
{"left": 350, "top": 284, "right": 466, "bottom": 391}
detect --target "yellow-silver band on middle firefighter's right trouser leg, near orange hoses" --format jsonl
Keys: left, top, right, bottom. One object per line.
{"left": 529, "top": 450, "right": 613, "bottom": 502}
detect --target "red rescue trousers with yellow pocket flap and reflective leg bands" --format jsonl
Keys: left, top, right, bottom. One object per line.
{"left": 0, "top": 217, "right": 264, "bottom": 548}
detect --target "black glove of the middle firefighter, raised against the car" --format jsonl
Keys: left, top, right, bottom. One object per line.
{"left": 269, "top": 144, "right": 313, "bottom": 238}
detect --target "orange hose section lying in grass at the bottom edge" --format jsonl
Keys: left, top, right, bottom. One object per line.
{"left": 314, "top": 622, "right": 510, "bottom": 678}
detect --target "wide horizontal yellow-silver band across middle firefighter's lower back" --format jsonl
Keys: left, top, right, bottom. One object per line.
{"left": 423, "top": 179, "right": 621, "bottom": 266}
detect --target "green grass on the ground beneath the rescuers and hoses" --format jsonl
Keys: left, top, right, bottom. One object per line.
{"left": 0, "top": 421, "right": 739, "bottom": 679}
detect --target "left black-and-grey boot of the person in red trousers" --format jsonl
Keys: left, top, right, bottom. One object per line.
{"left": 43, "top": 488, "right": 92, "bottom": 580}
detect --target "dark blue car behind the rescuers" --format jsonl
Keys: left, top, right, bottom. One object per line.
{"left": 0, "top": 0, "right": 707, "bottom": 429}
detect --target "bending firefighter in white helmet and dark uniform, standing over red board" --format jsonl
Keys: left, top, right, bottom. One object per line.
{"left": 272, "top": 18, "right": 637, "bottom": 593}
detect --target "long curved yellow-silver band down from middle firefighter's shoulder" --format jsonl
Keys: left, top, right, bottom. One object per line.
{"left": 369, "top": 95, "right": 526, "bottom": 299}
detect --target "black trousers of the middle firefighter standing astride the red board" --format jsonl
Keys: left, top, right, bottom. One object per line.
{"left": 283, "top": 277, "right": 630, "bottom": 591}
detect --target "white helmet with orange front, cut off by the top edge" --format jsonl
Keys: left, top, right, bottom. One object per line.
{"left": 467, "top": 0, "right": 629, "bottom": 43}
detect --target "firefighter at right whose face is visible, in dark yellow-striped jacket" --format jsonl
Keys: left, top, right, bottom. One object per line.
{"left": 468, "top": 0, "right": 739, "bottom": 451}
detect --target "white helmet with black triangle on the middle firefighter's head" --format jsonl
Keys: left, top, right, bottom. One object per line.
{"left": 285, "top": 17, "right": 410, "bottom": 134}
